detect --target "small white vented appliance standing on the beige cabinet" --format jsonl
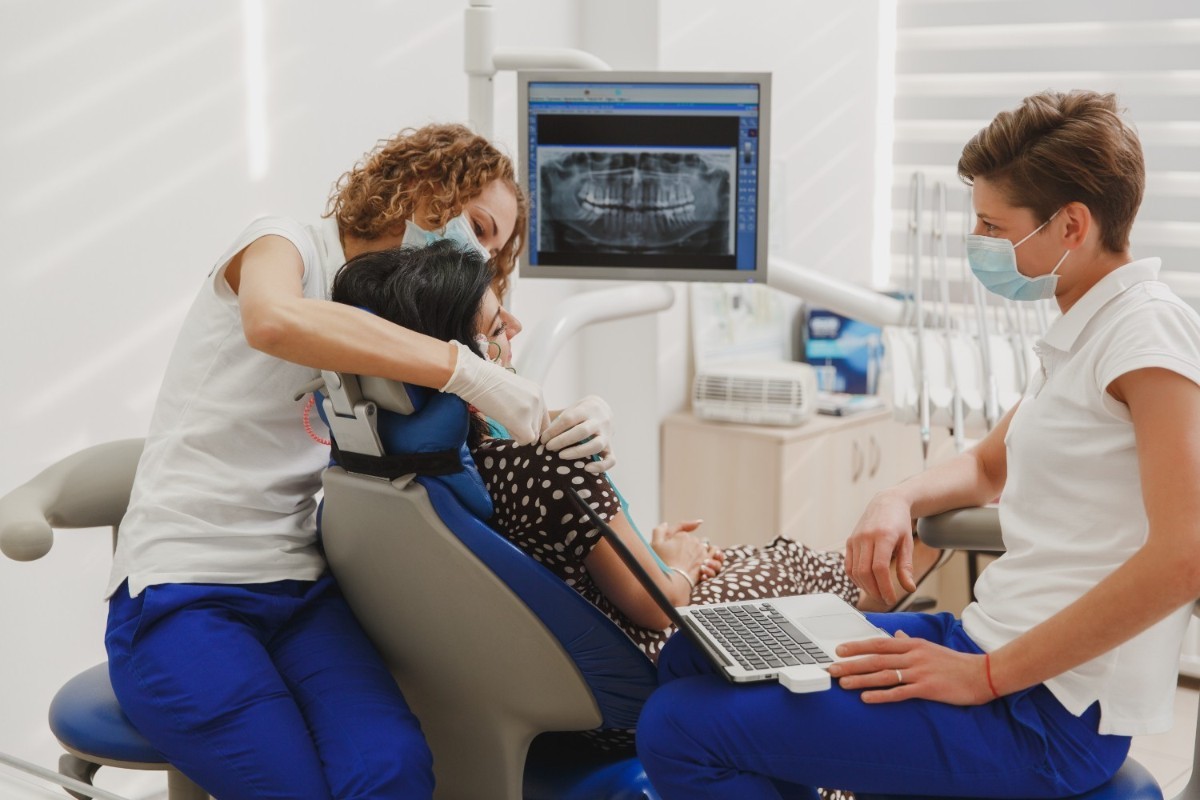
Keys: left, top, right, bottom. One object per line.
{"left": 691, "top": 361, "right": 817, "bottom": 426}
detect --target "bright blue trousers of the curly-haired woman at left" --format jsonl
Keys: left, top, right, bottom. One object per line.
{"left": 104, "top": 576, "right": 433, "bottom": 800}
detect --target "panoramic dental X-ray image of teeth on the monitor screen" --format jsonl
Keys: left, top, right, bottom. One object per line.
{"left": 538, "top": 148, "right": 737, "bottom": 255}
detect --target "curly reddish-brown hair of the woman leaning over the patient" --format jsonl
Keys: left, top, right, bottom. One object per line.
{"left": 325, "top": 125, "right": 528, "bottom": 297}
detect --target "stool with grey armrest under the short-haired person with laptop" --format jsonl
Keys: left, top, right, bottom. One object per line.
{"left": 857, "top": 506, "right": 1200, "bottom": 800}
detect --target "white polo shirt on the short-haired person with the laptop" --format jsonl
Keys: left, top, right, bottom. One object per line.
{"left": 962, "top": 258, "right": 1200, "bottom": 735}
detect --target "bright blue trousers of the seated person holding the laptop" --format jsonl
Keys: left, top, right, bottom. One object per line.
{"left": 637, "top": 614, "right": 1129, "bottom": 800}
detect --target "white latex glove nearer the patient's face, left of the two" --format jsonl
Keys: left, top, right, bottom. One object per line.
{"left": 442, "top": 342, "right": 550, "bottom": 444}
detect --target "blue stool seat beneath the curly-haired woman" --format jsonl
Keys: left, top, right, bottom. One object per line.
{"left": 50, "top": 663, "right": 167, "bottom": 769}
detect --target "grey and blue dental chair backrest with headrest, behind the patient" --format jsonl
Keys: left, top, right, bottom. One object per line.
{"left": 322, "top": 374, "right": 655, "bottom": 800}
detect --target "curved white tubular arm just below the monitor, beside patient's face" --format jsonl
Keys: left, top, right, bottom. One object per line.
{"left": 517, "top": 283, "right": 674, "bottom": 384}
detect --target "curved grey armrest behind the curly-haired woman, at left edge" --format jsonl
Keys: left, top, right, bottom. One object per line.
{"left": 0, "top": 439, "right": 144, "bottom": 561}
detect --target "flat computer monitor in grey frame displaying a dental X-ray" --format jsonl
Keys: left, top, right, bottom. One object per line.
{"left": 517, "top": 70, "right": 770, "bottom": 283}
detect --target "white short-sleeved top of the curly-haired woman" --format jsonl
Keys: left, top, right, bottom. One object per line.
{"left": 106, "top": 217, "right": 346, "bottom": 596}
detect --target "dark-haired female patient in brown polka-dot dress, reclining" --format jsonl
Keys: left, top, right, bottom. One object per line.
{"left": 332, "top": 241, "right": 937, "bottom": 661}
